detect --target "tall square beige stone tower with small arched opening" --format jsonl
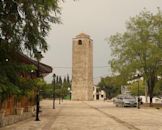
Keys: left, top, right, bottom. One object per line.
{"left": 72, "top": 33, "right": 93, "bottom": 101}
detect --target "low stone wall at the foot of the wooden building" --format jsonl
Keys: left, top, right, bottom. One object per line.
{"left": 0, "top": 112, "right": 33, "bottom": 127}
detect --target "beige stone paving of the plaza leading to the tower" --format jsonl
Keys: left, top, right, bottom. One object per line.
{"left": 0, "top": 100, "right": 162, "bottom": 130}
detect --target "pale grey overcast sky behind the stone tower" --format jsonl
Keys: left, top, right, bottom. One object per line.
{"left": 42, "top": 0, "right": 162, "bottom": 82}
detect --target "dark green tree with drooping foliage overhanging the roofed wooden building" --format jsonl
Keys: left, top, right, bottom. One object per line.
{"left": 0, "top": 0, "right": 60, "bottom": 101}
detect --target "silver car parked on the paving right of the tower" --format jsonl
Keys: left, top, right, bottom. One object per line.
{"left": 114, "top": 94, "right": 137, "bottom": 107}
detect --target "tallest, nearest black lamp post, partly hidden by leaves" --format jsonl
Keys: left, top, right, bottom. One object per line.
{"left": 35, "top": 51, "right": 42, "bottom": 121}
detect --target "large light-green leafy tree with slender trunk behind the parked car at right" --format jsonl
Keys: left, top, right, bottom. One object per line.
{"left": 108, "top": 9, "right": 162, "bottom": 105}
